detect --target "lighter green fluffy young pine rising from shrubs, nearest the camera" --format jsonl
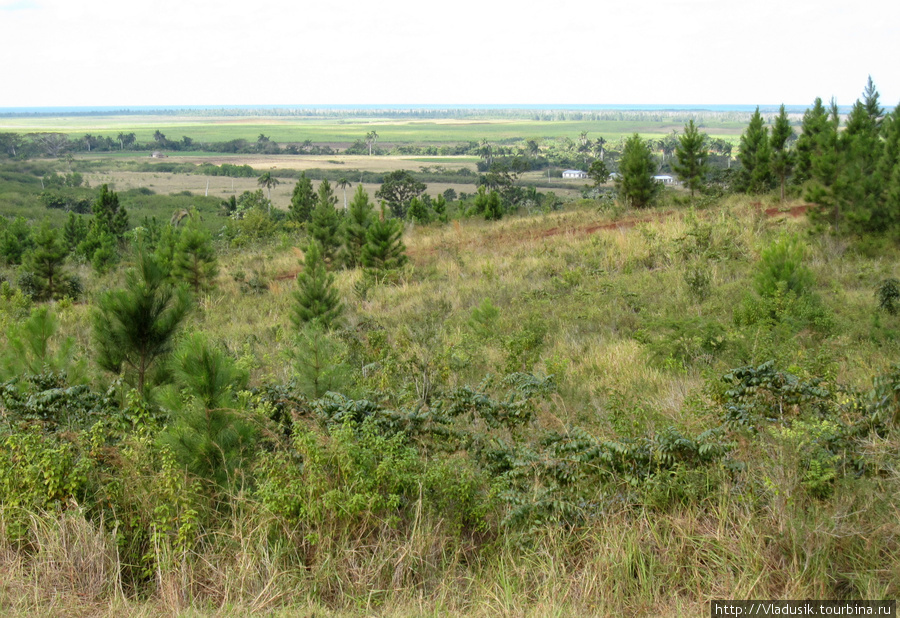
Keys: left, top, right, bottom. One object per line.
{"left": 159, "top": 334, "right": 257, "bottom": 487}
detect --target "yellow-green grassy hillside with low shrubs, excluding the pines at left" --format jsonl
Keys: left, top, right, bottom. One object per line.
{"left": 0, "top": 189, "right": 900, "bottom": 616}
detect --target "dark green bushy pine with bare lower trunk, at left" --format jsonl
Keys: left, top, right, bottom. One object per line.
{"left": 93, "top": 253, "right": 190, "bottom": 393}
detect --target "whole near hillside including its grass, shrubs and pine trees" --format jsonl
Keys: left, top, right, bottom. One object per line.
{"left": 0, "top": 84, "right": 900, "bottom": 615}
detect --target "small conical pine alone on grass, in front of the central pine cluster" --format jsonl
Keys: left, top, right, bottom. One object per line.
{"left": 291, "top": 241, "right": 344, "bottom": 330}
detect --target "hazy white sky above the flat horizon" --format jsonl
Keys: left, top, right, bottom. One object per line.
{"left": 0, "top": 0, "right": 900, "bottom": 108}
